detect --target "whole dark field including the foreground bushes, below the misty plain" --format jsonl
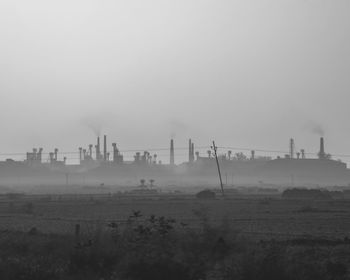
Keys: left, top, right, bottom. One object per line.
{"left": 0, "top": 190, "right": 350, "bottom": 280}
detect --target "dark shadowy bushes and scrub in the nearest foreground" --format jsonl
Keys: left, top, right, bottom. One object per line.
{"left": 0, "top": 209, "right": 350, "bottom": 280}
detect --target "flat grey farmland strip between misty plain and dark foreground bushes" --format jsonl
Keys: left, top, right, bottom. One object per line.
{"left": 0, "top": 192, "right": 350, "bottom": 239}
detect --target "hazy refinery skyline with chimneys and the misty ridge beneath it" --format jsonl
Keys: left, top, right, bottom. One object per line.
{"left": 0, "top": 135, "right": 350, "bottom": 188}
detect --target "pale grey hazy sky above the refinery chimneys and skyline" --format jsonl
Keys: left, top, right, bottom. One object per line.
{"left": 0, "top": 0, "right": 350, "bottom": 163}
